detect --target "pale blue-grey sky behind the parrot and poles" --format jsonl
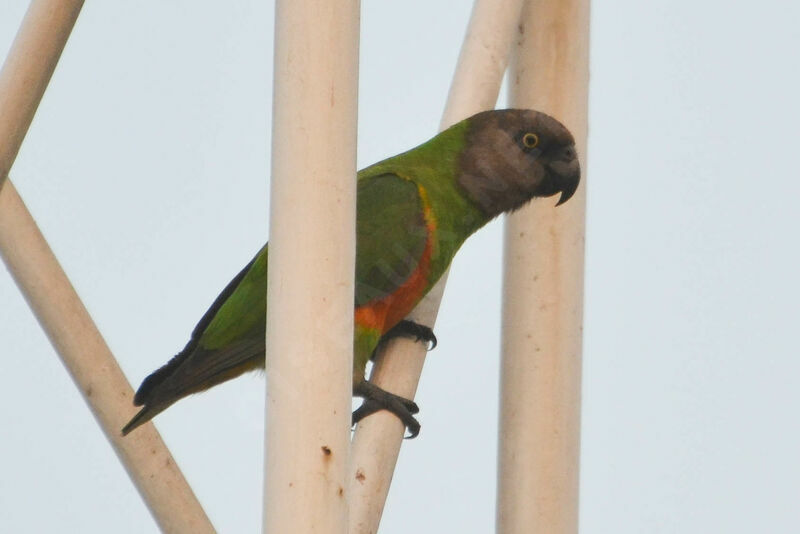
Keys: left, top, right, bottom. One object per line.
{"left": 0, "top": 0, "right": 800, "bottom": 534}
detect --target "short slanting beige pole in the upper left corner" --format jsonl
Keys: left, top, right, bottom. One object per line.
{"left": 0, "top": 0, "right": 83, "bottom": 188}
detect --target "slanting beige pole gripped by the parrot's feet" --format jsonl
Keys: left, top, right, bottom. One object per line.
{"left": 350, "top": 0, "right": 522, "bottom": 534}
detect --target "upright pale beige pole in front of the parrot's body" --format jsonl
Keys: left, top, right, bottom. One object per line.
{"left": 263, "top": 0, "right": 360, "bottom": 534}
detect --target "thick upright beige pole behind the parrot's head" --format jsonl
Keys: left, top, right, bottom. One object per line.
{"left": 497, "top": 0, "right": 589, "bottom": 534}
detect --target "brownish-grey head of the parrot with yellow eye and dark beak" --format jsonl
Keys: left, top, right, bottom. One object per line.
{"left": 458, "top": 109, "right": 581, "bottom": 217}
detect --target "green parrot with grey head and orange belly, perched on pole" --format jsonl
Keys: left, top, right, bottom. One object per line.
{"left": 122, "top": 109, "right": 580, "bottom": 437}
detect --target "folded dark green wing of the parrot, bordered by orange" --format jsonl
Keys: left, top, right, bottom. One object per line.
{"left": 355, "top": 173, "right": 428, "bottom": 307}
